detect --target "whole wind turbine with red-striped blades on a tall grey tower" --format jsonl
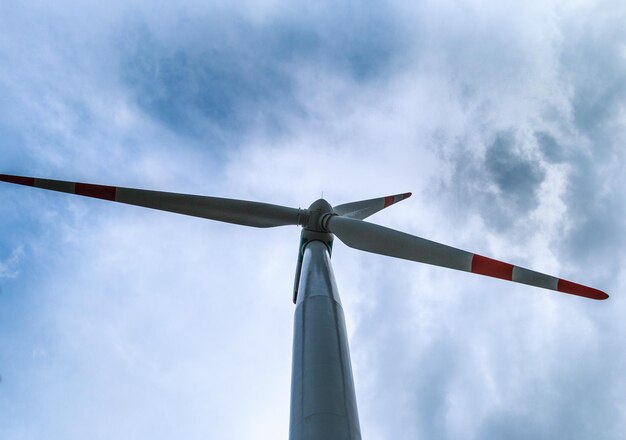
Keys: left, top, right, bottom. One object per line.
{"left": 0, "top": 174, "right": 608, "bottom": 440}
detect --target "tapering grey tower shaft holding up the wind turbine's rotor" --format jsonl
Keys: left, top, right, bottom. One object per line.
{"left": 289, "top": 241, "right": 361, "bottom": 440}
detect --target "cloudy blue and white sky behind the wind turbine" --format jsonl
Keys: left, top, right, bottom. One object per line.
{"left": 0, "top": 0, "right": 626, "bottom": 440}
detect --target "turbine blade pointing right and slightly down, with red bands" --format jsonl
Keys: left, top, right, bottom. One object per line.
{"left": 326, "top": 215, "right": 609, "bottom": 299}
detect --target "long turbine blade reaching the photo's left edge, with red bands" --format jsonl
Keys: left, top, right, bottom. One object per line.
{"left": 0, "top": 174, "right": 303, "bottom": 228}
